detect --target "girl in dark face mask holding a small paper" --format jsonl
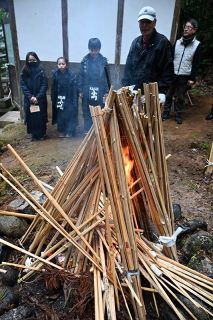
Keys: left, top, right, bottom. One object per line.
{"left": 20, "top": 51, "right": 48, "bottom": 141}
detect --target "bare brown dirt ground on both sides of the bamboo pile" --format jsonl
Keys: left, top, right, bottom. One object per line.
{"left": 0, "top": 96, "right": 213, "bottom": 231}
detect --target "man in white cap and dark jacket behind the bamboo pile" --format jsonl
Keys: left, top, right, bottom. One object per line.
{"left": 122, "top": 6, "right": 173, "bottom": 93}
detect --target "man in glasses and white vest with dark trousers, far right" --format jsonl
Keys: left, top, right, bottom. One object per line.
{"left": 162, "top": 19, "right": 201, "bottom": 124}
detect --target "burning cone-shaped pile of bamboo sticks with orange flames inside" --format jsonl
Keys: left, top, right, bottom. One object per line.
{"left": 0, "top": 83, "right": 213, "bottom": 320}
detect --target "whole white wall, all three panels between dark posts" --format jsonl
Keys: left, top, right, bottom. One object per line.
{"left": 14, "top": 0, "right": 175, "bottom": 63}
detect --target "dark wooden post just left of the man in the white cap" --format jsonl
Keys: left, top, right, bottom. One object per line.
{"left": 115, "top": 0, "right": 124, "bottom": 66}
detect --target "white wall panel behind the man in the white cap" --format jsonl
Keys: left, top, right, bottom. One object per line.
{"left": 121, "top": 0, "right": 175, "bottom": 63}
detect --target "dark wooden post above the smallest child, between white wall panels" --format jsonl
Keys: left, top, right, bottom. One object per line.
{"left": 61, "top": 0, "right": 69, "bottom": 61}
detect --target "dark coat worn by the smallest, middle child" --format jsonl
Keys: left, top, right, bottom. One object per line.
{"left": 51, "top": 69, "right": 78, "bottom": 124}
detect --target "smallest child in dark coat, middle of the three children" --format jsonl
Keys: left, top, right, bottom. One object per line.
{"left": 51, "top": 57, "right": 78, "bottom": 138}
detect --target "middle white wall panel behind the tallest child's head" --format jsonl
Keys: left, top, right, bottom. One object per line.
{"left": 68, "top": 0, "right": 117, "bottom": 63}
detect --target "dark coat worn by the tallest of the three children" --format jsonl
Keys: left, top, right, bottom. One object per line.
{"left": 78, "top": 53, "right": 108, "bottom": 100}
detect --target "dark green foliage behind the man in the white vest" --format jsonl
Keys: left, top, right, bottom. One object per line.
{"left": 178, "top": 0, "right": 213, "bottom": 75}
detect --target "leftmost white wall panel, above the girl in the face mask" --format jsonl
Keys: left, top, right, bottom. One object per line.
{"left": 14, "top": 0, "right": 63, "bottom": 61}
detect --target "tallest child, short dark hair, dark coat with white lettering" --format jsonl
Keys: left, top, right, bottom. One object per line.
{"left": 78, "top": 38, "right": 108, "bottom": 133}
